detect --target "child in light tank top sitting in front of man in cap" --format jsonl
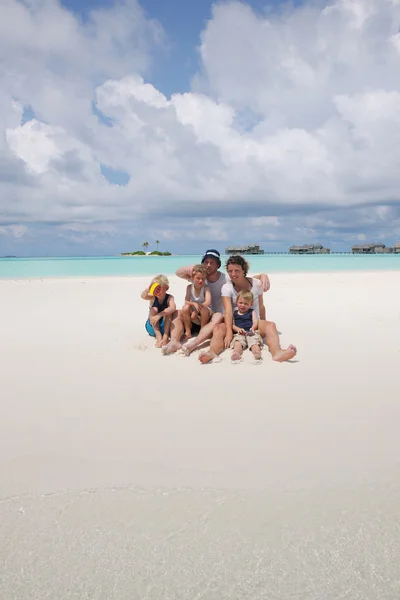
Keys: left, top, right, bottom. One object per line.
{"left": 182, "top": 265, "right": 212, "bottom": 340}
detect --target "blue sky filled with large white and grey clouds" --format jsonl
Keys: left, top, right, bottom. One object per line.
{"left": 0, "top": 0, "right": 400, "bottom": 256}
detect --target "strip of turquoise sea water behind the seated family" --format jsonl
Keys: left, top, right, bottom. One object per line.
{"left": 0, "top": 254, "right": 400, "bottom": 279}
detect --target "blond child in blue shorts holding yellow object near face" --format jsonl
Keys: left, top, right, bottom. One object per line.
{"left": 141, "top": 275, "right": 176, "bottom": 348}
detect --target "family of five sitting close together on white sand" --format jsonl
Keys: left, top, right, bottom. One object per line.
{"left": 141, "top": 249, "right": 297, "bottom": 364}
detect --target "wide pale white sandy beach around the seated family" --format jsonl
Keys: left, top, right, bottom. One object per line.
{"left": 0, "top": 272, "right": 400, "bottom": 600}
